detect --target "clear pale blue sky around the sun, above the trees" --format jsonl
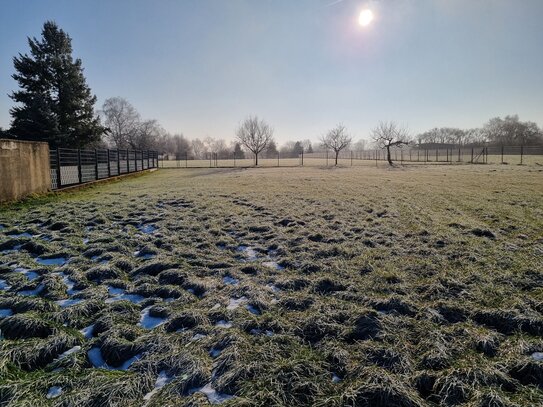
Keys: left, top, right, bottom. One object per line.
{"left": 0, "top": 0, "right": 543, "bottom": 143}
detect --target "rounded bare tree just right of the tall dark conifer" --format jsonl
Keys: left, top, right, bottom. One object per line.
{"left": 101, "top": 97, "right": 140, "bottom": 148}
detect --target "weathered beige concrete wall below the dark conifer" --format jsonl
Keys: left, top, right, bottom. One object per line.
{"left": 0, "top": 139, "right": 51, "bottom": 202}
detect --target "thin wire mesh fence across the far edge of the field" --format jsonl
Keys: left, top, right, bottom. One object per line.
{"left": 158, "top": 146, "right": 543, "bottom": 168}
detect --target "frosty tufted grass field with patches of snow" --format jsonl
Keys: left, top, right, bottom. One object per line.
{"left": 0, "top": 165, "right": 543, "bottom": 407}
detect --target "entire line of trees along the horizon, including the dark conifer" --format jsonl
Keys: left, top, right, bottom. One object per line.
{"left": 0, "top": 21, "right": 543, "bottom": 164}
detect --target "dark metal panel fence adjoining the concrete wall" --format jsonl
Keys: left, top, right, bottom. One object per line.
{"left": 49, "top": 148, "right": 158, "bottom": 189}
